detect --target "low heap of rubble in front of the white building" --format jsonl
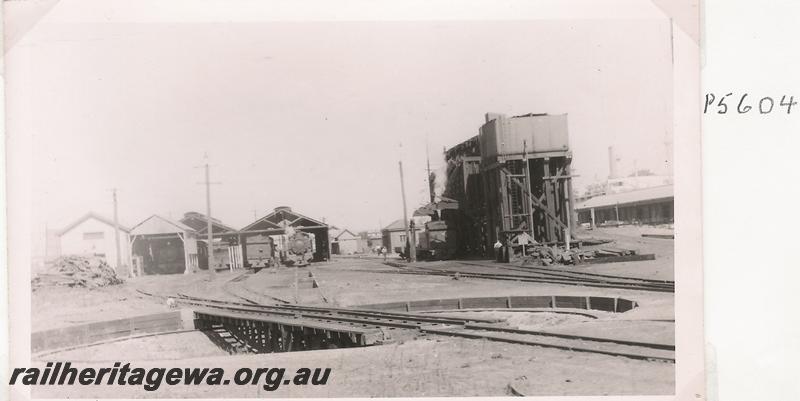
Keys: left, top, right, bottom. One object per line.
{"left": 31, "top": 256, "right": 123, "bottom": 290}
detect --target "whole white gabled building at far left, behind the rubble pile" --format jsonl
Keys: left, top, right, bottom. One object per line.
{"left": 57, "top": 212, "right": 131, "bottom": 269}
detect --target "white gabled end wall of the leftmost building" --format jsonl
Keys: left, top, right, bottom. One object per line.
{"left": 59, "top": 217, "right": 130, "bottom": 268}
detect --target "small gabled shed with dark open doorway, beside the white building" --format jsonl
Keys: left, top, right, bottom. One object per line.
{"left": 130, "top": 215, "right": 199, "bottom": 275}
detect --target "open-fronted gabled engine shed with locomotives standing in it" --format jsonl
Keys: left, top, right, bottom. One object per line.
{"left": 239, "top": 206, "right": 330, "bottom": 262}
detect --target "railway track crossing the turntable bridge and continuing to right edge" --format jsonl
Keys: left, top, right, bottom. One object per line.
{"left": 178, "top": 294, "right": 675, "bottom": 363}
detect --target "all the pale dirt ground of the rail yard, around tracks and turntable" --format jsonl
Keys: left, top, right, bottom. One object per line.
{"left": 32, "top": 223, "right": 675, "bottom": 398}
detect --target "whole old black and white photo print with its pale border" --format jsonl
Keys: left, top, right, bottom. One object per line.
{"left": 4, "top": 0, "right": 704, "bottom": 399}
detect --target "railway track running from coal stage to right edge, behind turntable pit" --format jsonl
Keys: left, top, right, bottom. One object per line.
{"left": 362, "top": 266, "right": 675, "bottom": 292}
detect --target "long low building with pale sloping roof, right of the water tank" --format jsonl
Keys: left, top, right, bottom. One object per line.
{"left": 575, "top": 185, "right": 675, "bottom": 226}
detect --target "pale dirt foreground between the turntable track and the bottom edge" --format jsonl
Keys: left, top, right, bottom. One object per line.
{"left": 34, "top": 338, "right": 674, "bottom": 398}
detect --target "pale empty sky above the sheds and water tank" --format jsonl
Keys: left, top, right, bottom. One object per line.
{"left": 6, "top": 6, "right": 673, "bottom": 241}
